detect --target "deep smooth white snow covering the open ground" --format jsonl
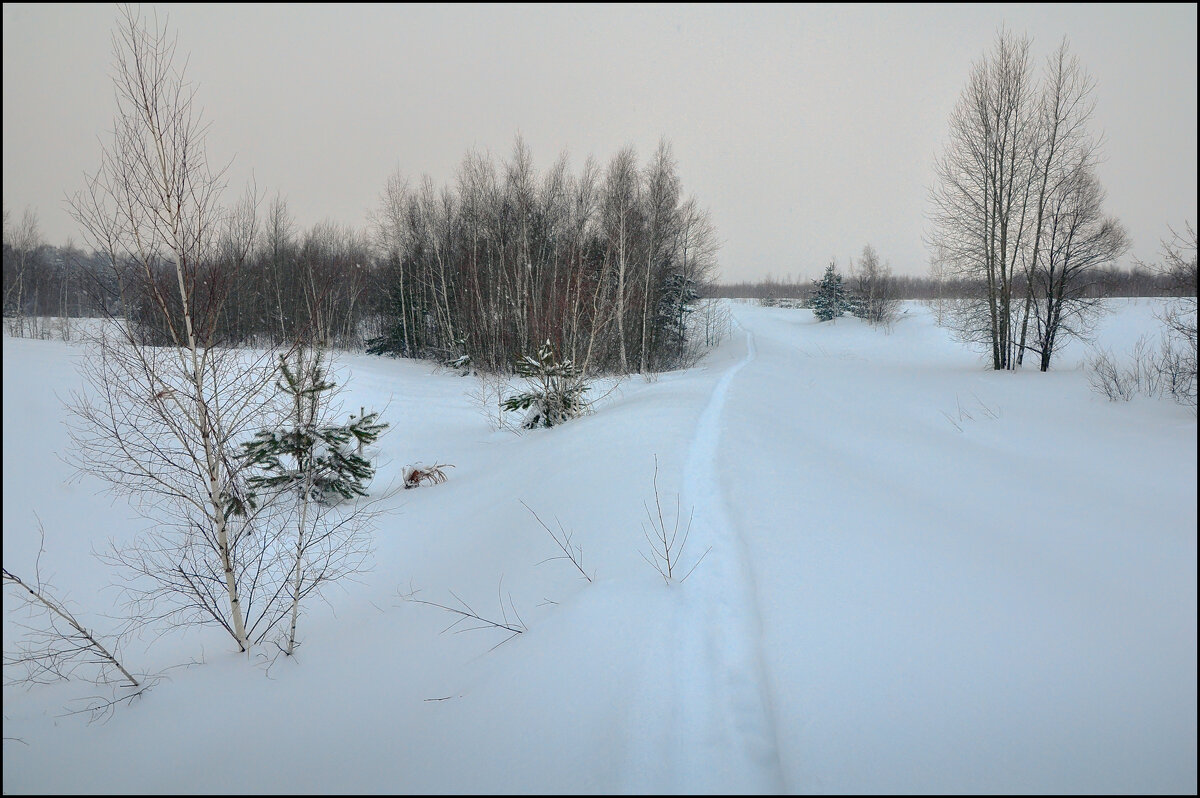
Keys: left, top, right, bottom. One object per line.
{"left": 4, "top": 300, "right": 1196, "bottom": 794}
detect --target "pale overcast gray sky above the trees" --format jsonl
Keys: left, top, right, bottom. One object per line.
{"left": 4, "top": 4, "right": 1196, "bottom": 281}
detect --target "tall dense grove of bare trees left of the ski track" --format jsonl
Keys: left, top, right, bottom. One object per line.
{"left": 370, "top": 139, "right": 716, "bottom": 372}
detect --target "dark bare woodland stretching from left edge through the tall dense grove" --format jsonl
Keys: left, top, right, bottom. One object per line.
{"left": 5, "top": 139, "right": 718, "bottom": 372}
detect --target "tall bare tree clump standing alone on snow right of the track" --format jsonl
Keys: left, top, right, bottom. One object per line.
{"left": 931, "top": 31, "right": 1128, "bottom": 371}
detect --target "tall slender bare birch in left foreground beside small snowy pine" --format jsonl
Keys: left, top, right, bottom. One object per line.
{"left": 71, "top": 6, "right": 274, "bottom": 652}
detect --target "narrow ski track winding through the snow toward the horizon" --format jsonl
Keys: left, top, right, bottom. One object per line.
{"left": 652, "top": 316, "right": 784, "bottom": 793}
